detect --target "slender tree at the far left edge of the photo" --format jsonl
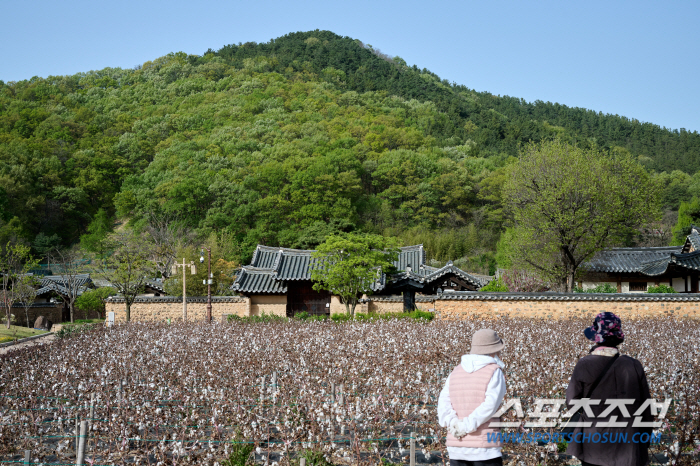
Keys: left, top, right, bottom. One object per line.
{"left": 0, "top": 242, "right": 38, "bottom": 329}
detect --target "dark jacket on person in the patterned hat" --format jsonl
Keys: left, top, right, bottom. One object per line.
{"left": 566, "top": 354, "right": 653, "bottom": 466}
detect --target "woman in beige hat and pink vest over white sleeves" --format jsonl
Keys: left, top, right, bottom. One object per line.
{"left": 438, "top": 329, "right": 506, "bottom": 466}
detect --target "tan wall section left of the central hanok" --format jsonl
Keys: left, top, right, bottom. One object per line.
{"left": 106, "top": 296, "right": 251, "bottom": 322}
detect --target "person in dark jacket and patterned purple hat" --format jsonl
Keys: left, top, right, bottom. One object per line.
{"left": 566, "top": 312, "right": 652, "bottom": 466}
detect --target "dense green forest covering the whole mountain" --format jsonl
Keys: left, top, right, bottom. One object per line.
{"left": 0, "top": 31, "right": 700, "bottom": 272}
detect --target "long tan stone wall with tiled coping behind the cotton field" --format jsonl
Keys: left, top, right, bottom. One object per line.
{"left": 106, "top": 292, "right": 700, "bottom": 322}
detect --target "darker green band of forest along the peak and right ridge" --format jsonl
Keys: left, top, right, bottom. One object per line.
{"left": 204, "top": 31, "right": 700, "bottom": 173}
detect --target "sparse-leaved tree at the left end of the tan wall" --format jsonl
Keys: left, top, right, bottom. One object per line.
{"left": 95, "top": 230, "right": 156, "bottom": 322}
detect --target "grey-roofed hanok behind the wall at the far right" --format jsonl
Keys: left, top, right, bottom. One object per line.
{"left": 580, "top": 226, "right": 700, "bottom": 293}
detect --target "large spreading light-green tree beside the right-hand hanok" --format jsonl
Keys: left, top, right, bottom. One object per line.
{"left": 503, "top": 140, "right": 661, "bottom": 292}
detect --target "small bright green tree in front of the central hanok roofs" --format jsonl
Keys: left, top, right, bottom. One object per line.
{"left": 311, "top": 233, "right": 399, "bottom": 317}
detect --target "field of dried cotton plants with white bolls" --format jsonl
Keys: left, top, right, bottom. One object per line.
{"left": 0, "top": 313, "right": 700, "bottom": 466}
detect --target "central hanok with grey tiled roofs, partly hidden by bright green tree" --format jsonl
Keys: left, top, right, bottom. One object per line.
{"left": 231, "top": 244, "right": 487, "bottom": 316}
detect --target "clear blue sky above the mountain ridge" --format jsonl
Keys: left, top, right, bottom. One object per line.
{"left": 0, "top": 0, "right": 700, "bottom": 131}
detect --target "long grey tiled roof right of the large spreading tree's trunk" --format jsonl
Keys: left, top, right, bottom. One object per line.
{"left": 584, "top": 246, "right": 681, "bottom": 273}
